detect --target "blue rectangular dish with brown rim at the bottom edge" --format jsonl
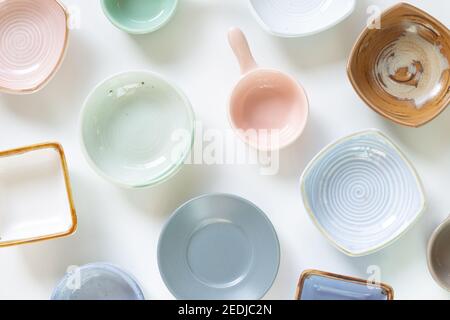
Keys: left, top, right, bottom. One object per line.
{"left": 296, "top": 270, "right": 394, "bottom": 300}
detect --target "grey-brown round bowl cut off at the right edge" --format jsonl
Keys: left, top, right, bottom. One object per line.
{"left": 428, "top": 218, "right": 450, "bottom": 291}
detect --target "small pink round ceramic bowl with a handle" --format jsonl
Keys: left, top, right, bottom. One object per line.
{"left": 228, "top": 28, "right": 309, "bottom": 151}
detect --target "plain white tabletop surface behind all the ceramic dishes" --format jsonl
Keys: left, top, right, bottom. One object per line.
{"left": 0, "top": 0, "right": 450, "bottom": 299}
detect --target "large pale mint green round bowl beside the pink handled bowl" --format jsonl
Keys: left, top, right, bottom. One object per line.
{"left": 81, "top": 71, "right": 194, "bottom": 188}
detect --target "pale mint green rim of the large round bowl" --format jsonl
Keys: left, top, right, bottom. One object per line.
{"left": 78, "top": 70, "right": 195, "bottom": 189}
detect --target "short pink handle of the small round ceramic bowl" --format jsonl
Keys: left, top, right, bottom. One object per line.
{"left": 228, "top": 28, "right": 258, "bottom": 74}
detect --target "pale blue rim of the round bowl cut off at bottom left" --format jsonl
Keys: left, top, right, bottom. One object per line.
{"left": 50, "top": 262, "right": 145, "bottom": 300}
